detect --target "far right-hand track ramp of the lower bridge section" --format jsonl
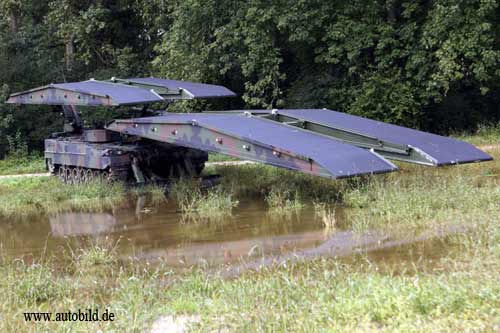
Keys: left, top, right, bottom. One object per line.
{"left": 257, "top": 109, "right": 492, "bottom": 166}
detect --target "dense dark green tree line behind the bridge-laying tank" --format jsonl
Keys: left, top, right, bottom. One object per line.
{"left": 0, "top": 0, "right": 500, "bottom": 156}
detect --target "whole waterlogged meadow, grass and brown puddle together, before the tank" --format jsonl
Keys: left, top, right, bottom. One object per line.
{"left": 0, "top": 131, "right": 500, "bottom": 332}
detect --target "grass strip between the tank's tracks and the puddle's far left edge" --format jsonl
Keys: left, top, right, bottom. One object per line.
{"left": 0, "top": 177, "right": 125, "bottom": 217}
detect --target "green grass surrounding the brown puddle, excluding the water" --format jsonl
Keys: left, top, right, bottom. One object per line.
{"left": 0, "top": 124, "right": 500, "bottom": 332}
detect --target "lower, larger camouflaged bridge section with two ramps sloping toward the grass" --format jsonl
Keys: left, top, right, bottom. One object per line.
{"left": 108, "top": 109, "right": 492, "bottom": 178}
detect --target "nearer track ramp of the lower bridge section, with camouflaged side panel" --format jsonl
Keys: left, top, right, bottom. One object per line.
{"left": 107, "top": 113, "right": 397, "bottom": 178}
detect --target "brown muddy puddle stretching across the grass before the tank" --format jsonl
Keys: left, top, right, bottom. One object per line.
{"left": 0, "top": 198, "right": 453, "bottom": 268}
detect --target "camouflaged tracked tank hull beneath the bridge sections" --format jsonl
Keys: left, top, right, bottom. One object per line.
{"left": 45, "top": 115, "right": 208, "bottom": 184}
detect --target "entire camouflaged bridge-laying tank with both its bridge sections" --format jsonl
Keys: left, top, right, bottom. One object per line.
{"left": 7, "top": 78, "right": 492, "bottom": 183}
